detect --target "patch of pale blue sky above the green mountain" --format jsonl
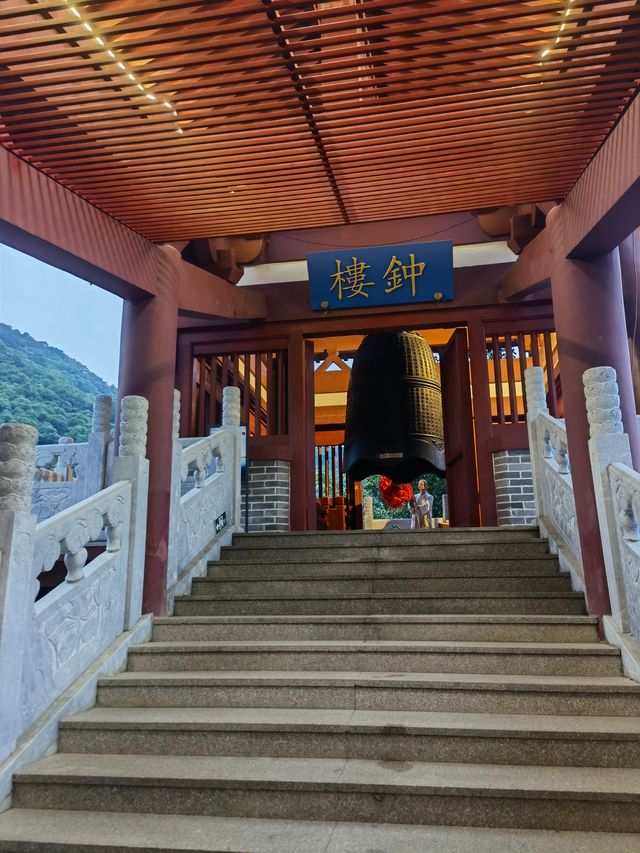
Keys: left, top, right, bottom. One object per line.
{"left": 0, "top": 243, "right": 122, "bottom": 385}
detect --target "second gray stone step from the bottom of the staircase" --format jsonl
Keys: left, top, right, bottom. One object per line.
{"left": 13, "top": 753, "right": 640, "bottom": 833}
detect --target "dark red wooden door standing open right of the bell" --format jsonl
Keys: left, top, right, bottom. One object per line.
{"left": 440, "top": 329, "right": 480, "bottom": 527}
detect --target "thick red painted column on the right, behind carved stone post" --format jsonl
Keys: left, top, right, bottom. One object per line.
{"left": 547, "top": 207, "right": 640, "bottom": 616}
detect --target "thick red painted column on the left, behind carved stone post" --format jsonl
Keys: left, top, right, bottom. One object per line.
{"left": 118, "top": 246, "right": 180, "bottom": 615}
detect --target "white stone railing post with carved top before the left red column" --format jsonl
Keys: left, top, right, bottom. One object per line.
{"left": 113, "top": 396, "right": 149, "bottom": 631}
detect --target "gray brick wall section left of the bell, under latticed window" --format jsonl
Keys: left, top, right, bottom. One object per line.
{"left": 242, "top": 460, "right": 290, "bottom": 533}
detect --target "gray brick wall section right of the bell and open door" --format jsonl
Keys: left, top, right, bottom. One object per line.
{"left": 493, "top": 450, "right": 536, "bottom": 526}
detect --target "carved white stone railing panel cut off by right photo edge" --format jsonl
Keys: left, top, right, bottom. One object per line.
{"left": 609, "top": 464, "right": 640, "bottom": 642}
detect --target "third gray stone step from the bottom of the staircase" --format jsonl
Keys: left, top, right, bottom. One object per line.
{"left": 58, "top": 708, "right": 640, "bottom": 767}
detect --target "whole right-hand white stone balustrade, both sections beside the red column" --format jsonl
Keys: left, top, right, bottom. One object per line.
{"left": 525, "top": 366, "right": 640, "bottom": 681}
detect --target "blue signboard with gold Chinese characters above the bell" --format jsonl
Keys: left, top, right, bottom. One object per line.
{"left": 307, "top": 240, "right": 453, "bottom": 311}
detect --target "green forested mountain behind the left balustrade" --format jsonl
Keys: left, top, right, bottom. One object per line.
{"left": 0, "top": 323, "right": 116, "bottom": 444}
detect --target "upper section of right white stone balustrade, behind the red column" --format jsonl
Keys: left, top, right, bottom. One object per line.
{"left": 525, "top": 367, "right": 584, "bottom": 590}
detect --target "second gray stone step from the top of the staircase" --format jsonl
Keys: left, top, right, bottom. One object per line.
{"left": 220, "top": 543, "right": 558, "bottom": 569}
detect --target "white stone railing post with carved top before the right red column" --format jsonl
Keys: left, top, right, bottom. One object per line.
{"left": 582, "top": 367, "right": 633, "bottom": 633}
